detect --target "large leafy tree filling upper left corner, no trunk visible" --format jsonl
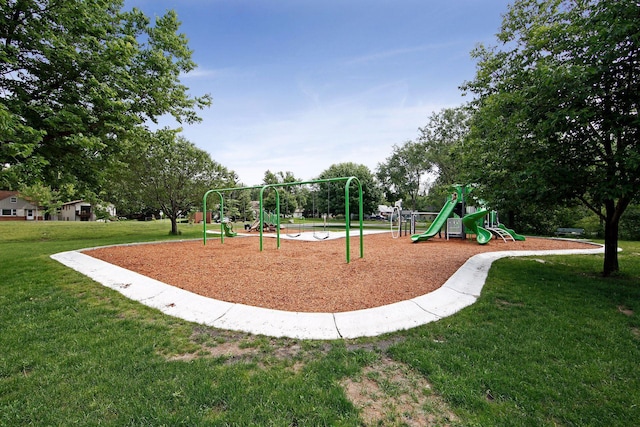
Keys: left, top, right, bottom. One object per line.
{"left": 0, "top": 0, "right": 210, "bottom": 193}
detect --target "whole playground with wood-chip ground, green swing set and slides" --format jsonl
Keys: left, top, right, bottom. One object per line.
{"left": 80, "top": 177, "right": 593, "bottom": 313}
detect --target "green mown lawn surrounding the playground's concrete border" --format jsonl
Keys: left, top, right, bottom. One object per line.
{"left": 0, "top": 222, "right": 640, "bottom": 426}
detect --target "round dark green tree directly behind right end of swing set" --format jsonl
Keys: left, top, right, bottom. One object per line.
{"left": 314, "top": 162, "right": 382, "bottom": 219}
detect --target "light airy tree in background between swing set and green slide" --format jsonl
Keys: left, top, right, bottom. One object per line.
{"left": 376, "top": 141, "right": 432, "bottom": 210}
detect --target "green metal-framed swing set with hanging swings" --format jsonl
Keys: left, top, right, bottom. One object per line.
{"left": 202, "top": 176, "right": 364, "bottom": 263}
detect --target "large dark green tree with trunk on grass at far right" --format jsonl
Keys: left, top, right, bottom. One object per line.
{"left": 463, "top": 0, "right": 640, "bottom": 276}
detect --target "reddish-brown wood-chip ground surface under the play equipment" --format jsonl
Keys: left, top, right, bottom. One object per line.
{"left": 85, "top": 232, "right": 594, "bottom": 313}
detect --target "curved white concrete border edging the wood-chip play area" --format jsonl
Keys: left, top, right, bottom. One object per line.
{"left": 51, "top": 239, "right": 604, "bottom": 340}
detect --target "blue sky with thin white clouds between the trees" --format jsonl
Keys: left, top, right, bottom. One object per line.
{"left": 125, "top": 0, "right": 509, "bottom": 185}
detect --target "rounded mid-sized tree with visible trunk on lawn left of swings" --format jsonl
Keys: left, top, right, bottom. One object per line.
{"left": 114, "top": 129, "right": 235, "bottom": 235}
